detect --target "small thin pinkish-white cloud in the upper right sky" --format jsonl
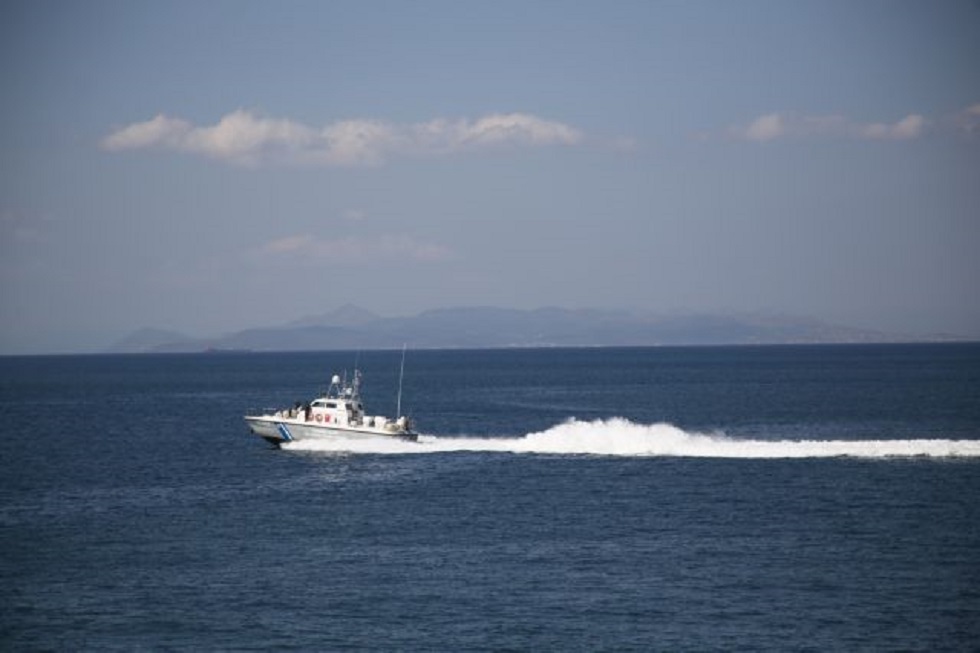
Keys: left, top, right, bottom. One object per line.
{"left": 729, "top": 113, "right": 927, "bottom": 142}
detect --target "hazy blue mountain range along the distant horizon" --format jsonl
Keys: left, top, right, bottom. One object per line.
{"left": 109, "top": 305, "right": 942, "bottom": 353}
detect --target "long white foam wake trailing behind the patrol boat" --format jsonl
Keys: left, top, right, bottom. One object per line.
{"left": 284, "top": 418, "right": 980, "bottom": 458}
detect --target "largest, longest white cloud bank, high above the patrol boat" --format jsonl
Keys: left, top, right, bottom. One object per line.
{"left": 102, "top": 109, "right": 583, "bottom": 166}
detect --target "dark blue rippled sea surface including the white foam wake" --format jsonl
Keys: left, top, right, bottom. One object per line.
{"left": 0, "top": 344, "right": 980, "bottom": 651}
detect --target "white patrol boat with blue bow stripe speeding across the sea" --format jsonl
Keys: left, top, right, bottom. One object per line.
{"left": 245, "top": 370, "right": 419, "bottom": 446}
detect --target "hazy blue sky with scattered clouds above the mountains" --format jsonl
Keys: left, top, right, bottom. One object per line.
{"left": 0, "top": 0, "right": 980, "bottom": 353}
